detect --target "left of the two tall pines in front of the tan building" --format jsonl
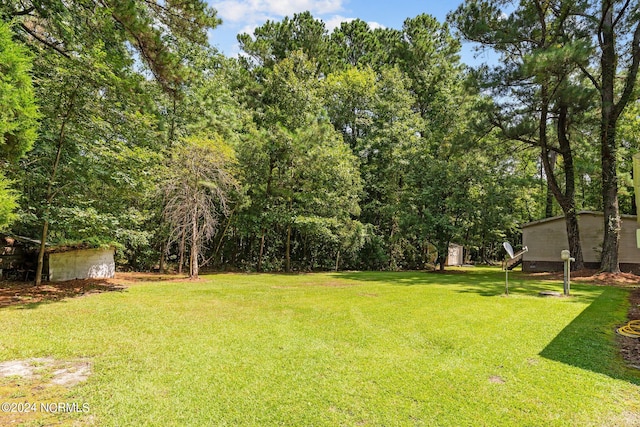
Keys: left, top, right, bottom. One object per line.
{"left": 450, "top": 0, "right": 596, "bottom": 269}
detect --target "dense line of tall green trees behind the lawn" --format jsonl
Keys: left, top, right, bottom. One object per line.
{"left": 0, "top": 0, "right": 640, "bottom": 277}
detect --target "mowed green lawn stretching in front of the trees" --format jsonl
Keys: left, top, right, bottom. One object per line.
{"left": 0, "top": 269, "right": 640, "bottom": 426}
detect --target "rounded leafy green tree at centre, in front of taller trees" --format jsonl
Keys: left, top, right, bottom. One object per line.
{"left": 239, "top": 118, "right": 361, "bottom": 267}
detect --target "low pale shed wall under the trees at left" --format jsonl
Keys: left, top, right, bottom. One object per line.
{"left": 49, "top": 249, "right": 116, "bottom": 282}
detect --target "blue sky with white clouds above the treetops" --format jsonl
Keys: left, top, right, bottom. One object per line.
{"left": 209, "top": 0, "right": 496, "bottom": 65}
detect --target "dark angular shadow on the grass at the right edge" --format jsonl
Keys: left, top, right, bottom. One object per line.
{"left": 540, "top": 288, "right": 640, "bottom": 385}
